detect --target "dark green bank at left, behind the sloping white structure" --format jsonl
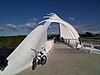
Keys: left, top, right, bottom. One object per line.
{"left": 0, "top": 36, "right": 26, "bottom": 50}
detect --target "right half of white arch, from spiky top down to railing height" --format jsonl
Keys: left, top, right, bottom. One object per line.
{"left": 40, "top": 13, "right": 79, "bottom": 39}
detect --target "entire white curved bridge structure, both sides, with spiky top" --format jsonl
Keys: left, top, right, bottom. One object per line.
{"left": 0, "top": 13, "right": 79, "bottom": 75}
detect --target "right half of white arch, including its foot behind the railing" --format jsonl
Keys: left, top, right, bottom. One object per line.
{"left": 40, "top": 13, "right": 80, "bottom": 48}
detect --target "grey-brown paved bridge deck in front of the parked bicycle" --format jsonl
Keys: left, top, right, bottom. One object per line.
{"left": 17, "top": 43, "right": 100, "bottom": 75}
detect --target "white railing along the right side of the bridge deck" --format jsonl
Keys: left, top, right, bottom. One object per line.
{"left": 63, "top": 39, "right": 100, "bottom": 52}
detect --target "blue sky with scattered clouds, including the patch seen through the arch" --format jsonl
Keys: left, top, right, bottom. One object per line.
{"left": 0, "top": 0, "right": 100, "bottom": 36}
